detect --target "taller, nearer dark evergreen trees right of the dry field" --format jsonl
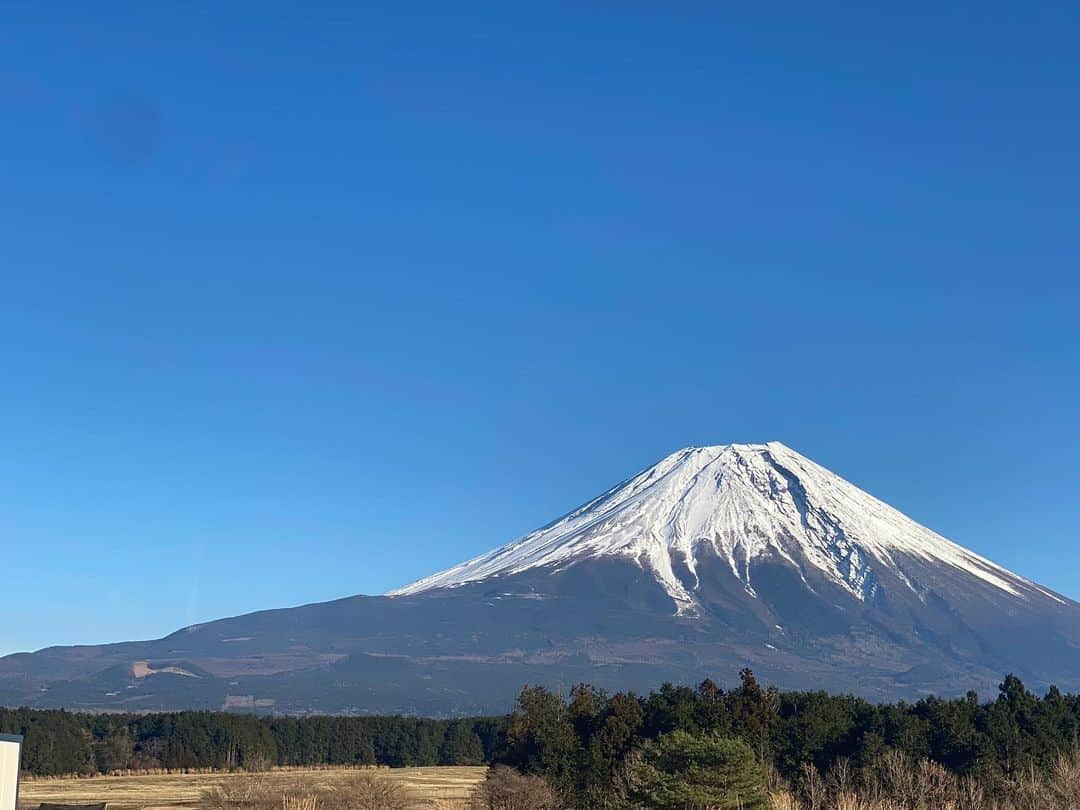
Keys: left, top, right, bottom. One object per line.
{"left": 501, "top": 670, "right": 1080, "bottom": 808}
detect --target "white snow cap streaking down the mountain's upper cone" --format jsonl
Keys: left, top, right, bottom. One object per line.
{"left": 388, "top": 442, "right": 1062, "bottom": 615}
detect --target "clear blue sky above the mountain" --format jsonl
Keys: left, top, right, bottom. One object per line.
{"left": 0, "top": 2, "right": 1080, "bottom": 652}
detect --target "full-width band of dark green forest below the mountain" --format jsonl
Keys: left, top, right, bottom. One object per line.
{"left": 0, "top": 671, "right": 1080, "bottom": 798}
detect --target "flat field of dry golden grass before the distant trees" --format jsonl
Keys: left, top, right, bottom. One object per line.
{"left": 18, "top": 767, "right": 486, "bottom": 810}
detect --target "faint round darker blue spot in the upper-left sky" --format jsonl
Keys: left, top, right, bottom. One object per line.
{"left": 87, "top": 95, "right": 164, "bottom": 166}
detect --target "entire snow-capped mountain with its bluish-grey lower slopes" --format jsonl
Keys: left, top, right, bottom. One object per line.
{"left": 0, "top": 442, "right": 1080, "bottom": 715}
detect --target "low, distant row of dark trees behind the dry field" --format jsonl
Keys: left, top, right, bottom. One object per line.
{"left": 0, "top": 708, "right": 507, "bottom": 775}
